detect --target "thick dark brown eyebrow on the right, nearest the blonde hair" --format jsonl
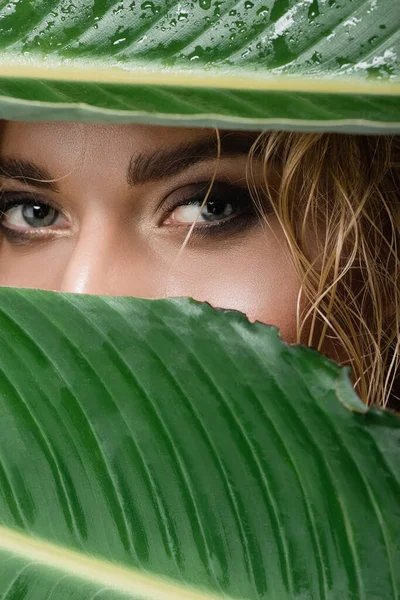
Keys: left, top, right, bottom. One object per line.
{"left": 127, "top": 132, "right": 257, "bottom": 186}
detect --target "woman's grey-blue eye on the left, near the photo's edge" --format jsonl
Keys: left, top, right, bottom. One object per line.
{"left": 1, "top": 202, "right": 65, "bottom": 230}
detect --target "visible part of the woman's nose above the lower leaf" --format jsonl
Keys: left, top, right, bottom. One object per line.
{"left": 60, "top": 221, "right": 116, "bottom": 294}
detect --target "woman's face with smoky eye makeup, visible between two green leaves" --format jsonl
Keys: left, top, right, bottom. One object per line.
{"left": 0, "top": 122, "right": 299, "bottom": 341}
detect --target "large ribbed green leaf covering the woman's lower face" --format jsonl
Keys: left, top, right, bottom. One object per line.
{"left": 0, "top": 288, "right": 400, "bottom": 600}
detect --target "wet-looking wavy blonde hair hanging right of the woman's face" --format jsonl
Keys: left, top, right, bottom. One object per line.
{"left": 247, "top": 131, "right": 400, "bottom": 406}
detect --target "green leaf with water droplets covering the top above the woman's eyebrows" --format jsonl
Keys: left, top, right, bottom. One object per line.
{"left": 0, "top": 0, "right": 400, "bottom": 132}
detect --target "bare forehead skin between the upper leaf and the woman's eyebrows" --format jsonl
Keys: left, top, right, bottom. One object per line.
{"left": 0, "top": 121, "right": 210, "bottom": 185}
